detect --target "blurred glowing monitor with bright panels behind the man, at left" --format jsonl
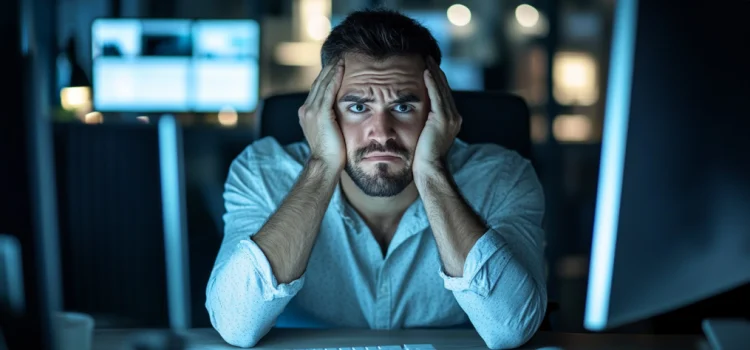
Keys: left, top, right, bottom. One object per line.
{"left": 91, "top": 18, "right": 260, "bottom": 112}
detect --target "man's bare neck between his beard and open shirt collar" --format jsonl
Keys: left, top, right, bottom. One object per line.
{"left": 341, "top": 172, "right": 419, "bottom": 225}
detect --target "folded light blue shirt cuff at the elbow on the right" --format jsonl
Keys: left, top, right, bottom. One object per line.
{"left": 439, "top": 229, "right": 511, "bottom": 297}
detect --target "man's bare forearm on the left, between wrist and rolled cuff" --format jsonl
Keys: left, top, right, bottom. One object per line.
{"left": 252, "top": 160, "right": 341, "bottom": 283}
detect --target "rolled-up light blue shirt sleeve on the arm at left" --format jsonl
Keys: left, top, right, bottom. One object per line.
{"left": 206, "top": 150, "right": 305, "bottom": 347}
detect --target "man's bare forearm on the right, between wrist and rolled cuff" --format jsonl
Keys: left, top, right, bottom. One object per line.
{"left": 414, "top": 166, "right": 487, "bottom": 277}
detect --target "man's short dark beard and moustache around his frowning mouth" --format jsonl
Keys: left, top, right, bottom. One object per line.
{"left": 344, "top": 140, "right": 413, "bottom": 197}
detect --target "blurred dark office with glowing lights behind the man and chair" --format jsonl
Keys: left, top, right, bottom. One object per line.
{"left": 32, "top": 0, "right": 737, "bottom": 332}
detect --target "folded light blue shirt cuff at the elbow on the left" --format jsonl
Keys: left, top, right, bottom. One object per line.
{"left": 238, "top": 239, "right": 305, "bottom": 301}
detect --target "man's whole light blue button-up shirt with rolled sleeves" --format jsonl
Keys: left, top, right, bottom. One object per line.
{"left": 206, "top": 138, "right": 547, "bottom": 349}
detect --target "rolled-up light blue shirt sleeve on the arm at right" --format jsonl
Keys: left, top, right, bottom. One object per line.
{"left": 439, "top": 160, "right": 547, "bottom": 349}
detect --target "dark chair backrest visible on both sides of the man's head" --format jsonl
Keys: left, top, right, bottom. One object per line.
{"left": 256, "top": 91, "right": 531, "bottom": 159}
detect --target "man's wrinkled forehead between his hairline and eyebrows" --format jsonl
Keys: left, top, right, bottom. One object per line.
{"left": 341, "top": 54, "right": 425, "bottom": 92}
